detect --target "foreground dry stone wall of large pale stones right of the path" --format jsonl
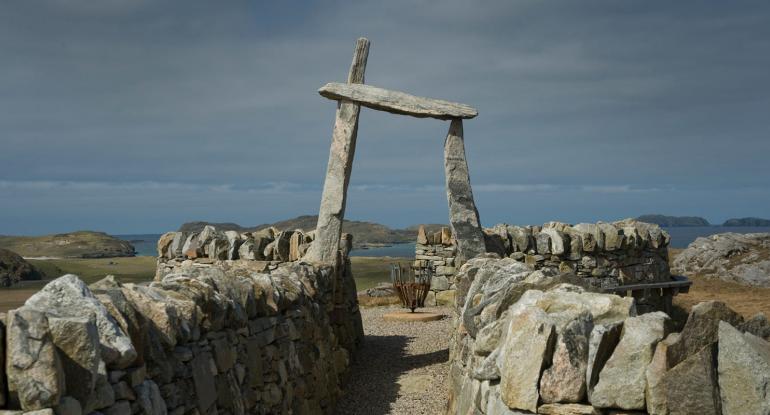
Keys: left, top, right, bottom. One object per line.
{"left": 447, "top": 258, "right": 770, "bottom": 415}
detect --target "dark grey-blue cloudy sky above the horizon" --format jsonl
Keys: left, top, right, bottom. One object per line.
{"left": 0, "top": 0, "right": 770, "bottom": 234}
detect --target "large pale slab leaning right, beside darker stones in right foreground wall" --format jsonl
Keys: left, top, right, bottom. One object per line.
{"left": 591, "top": 311, "right": 669, "bottom": 409}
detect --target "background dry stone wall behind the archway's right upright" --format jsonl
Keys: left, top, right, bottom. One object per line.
{"left": 413, "top": 219, "right": 671, "bottom": 312}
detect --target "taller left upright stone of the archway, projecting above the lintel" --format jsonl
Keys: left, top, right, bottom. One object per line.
{"left": 304, "top": 38, "right": 369, "bottom": 263}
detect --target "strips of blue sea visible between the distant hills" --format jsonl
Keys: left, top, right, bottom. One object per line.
{"left": 115, "top": 226, "right": 770, "bottom": 257}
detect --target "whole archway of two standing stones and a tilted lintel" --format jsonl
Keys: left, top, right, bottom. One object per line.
{"left": 303, "top": 38, "right": 486, "bottom": 263}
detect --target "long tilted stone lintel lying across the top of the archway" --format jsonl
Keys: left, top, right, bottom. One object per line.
{"left": 318, "top": 82, "right": 479, "bottom": 120}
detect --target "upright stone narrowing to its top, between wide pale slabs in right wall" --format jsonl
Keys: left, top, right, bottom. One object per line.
{"left": 540, "top": 311, "right": 593, "bottom": 403}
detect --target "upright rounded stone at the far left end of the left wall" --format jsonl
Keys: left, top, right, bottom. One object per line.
{"left": 6, "top": 307, "right": 64, "bottom": 411}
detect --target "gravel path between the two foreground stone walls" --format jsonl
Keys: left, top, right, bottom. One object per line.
{"left": 337, "top": 307, "right": 452, "bottom": 415}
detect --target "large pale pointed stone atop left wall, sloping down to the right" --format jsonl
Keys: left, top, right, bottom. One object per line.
{"left": 25, "top": 274, "right": 137, "bottom": 367}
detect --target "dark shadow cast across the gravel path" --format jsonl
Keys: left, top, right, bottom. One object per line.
{"left": 336, "top": 336, "right": 449, "bottom": 415}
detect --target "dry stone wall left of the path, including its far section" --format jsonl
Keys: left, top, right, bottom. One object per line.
{"left": 0, "top": 229, "right": 363, "bottom": 415}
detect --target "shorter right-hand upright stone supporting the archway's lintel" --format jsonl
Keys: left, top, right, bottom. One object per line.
{"left": 444, "top": 119, "right": 486, "bottom": 266}
